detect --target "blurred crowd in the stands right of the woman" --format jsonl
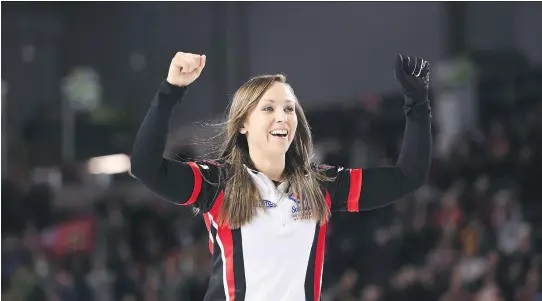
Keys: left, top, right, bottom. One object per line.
{"left": 323, "top": 102, "right": 542, "bottom": 301}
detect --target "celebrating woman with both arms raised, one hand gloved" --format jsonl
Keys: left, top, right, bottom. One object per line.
{"left": 131, "top": 52, "right": 431, "bottom": 301}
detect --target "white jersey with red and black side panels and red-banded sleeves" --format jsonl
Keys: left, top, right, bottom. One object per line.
{"left": 185, "top": 162, "right": 361, "bottom": 301}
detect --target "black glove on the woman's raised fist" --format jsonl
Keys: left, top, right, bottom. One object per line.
{"left": 395, "top": 54, "right": 430, "bottom": 106}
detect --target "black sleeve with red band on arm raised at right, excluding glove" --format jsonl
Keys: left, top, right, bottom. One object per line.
{"left": 326, "top": 102, "right": 432, "bottom": 212}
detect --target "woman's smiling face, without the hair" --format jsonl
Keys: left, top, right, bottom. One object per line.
{"left": 239, "top": 82, "right": 297, "bottom": 157}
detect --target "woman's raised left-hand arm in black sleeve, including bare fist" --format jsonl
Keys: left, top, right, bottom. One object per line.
{"left": 131, "top": 53, "right": 219, "bottom": 205}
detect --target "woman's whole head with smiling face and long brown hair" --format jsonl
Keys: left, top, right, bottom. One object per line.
{"left": 218, "top": 74, "right": 330, "bottom": 228}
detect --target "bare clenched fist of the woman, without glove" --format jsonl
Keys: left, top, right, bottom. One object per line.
{"left": 167, "top": 52, "right": 206, "bottom": 87}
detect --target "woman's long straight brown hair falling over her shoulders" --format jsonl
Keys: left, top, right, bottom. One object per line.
{"left": 217, "top": 74, "right": 330, "bottom": 228}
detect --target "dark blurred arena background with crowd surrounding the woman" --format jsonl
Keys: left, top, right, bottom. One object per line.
{"left": 1, "top": 2, "right": 542, "bottom": 301}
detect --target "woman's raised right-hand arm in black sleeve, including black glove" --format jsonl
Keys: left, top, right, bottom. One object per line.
{"left": 328, "top": 55, "right": 432, "bottom": 212}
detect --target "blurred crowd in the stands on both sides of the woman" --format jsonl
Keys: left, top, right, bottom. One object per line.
{"left": 2, "top": 65, "right": 542, "bottom": 301}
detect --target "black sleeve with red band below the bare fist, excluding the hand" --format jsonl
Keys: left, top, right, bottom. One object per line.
{"left": 131, "top": 81, "right": 222, "bottom": 211}
